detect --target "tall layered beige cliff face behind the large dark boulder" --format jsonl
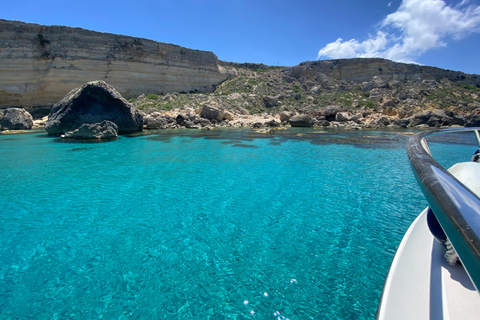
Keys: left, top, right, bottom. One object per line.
{"left": 0, "top": 19, "right": 227, "bottom": 108}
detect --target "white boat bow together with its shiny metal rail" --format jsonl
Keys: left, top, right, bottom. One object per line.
{"left": 377, "top": 131, "right": 480, "bottom": 320}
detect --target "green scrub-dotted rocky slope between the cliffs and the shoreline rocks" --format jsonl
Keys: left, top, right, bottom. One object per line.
{"left": 128, "top": 66, "right": 480, "bottom": 114}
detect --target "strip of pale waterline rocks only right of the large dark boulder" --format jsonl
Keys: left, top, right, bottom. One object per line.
{"left": 137, "top": 106, "right": 480, "bottom": 130}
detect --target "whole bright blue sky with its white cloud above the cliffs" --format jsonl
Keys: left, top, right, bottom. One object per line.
{"left": 0, "top": 0, "right": 480, "bottom": 74}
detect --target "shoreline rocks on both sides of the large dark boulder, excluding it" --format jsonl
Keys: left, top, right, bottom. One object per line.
{"left": 0, "top": 93, "right": 480, "bottom": 133}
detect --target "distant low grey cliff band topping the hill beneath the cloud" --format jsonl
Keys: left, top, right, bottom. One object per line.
{"left": 285, "top": 58, "right": 480, "bottom": 85}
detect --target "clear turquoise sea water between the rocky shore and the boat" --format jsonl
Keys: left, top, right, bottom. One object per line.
{"left": 0, "top": 130, "right": 475, "bottom": 319}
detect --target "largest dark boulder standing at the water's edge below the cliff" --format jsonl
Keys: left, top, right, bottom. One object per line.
{"left": 45, "top": 81, "right": 143, "bottom": 135}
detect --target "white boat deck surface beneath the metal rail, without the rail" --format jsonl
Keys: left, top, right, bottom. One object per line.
{"left": 377, "top": 162, "right": 480, "bottom": 320}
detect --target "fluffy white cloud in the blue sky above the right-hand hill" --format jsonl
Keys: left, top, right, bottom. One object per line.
{"left": 318, "top": 0, "right": 480, "bottom": 62}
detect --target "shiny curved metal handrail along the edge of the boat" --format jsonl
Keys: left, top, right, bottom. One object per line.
{"left": 407, "top": 128, "right": 480, "bottom": 291}
